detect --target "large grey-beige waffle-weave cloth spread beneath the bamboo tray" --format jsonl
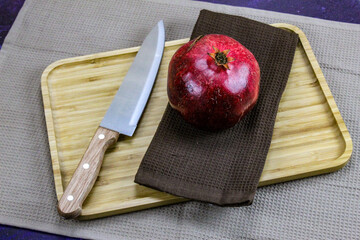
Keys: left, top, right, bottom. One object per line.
{"left": 0, "top": 0, "right": 360, "bottom": 240}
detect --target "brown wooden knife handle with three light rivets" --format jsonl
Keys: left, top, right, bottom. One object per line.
{"left": 57, "top": 127, "right": 119, "bottom": 218}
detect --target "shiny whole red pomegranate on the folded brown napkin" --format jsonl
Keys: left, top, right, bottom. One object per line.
{"left": 167, "top": 34, "right": 260, "bottom": 130}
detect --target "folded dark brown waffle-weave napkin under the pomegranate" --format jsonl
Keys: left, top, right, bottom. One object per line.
{"left": 135, "top": 10, "right": 298, "bottom": 205}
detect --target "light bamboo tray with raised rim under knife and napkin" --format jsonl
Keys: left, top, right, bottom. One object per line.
{"left": 41, "top": 24, "right": 352, "bottom": 219}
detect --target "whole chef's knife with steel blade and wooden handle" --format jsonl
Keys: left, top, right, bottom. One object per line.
{"left": 58, "top": 21, "right": 165, "bottom": 218}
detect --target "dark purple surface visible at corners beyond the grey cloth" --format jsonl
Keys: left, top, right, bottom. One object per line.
{"left": 0, "top": 0, "right": 360, "bottom": 240}
